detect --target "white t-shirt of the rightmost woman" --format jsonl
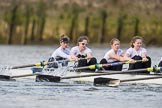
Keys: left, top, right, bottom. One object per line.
{"left": 126, "top": 47, "right": 147, "bottom": 58}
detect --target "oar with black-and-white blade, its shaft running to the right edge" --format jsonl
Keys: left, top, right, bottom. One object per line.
{"left": 94, "top": 75, "right": 162, "bottom": 87}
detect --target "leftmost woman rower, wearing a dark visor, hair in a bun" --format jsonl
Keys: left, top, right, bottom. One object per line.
{"left": 48, "top": 34, "right": 70, "bottom": 68}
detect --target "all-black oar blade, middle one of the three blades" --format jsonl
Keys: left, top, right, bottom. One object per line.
{"left": 36, "top": 75, "right": 61, "bottom": 82}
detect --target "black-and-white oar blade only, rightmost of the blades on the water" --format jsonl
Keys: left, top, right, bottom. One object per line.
{"left": 94, "top": 77, "right": 120, "bottom": 87}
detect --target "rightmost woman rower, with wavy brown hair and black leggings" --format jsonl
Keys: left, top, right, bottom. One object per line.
{"left": 125, "top": 36, "right": 151, "bottom": 70}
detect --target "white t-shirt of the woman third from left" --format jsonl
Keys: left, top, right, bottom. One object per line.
{"left": 104, "top": 49, "right": 123, "bottom": 62}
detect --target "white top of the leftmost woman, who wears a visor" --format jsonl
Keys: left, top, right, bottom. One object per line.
{"left": 51, "top": 47, "right": 71, "bottom": 59}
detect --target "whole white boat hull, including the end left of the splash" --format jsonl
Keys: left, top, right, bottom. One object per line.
{"left": 7, "top": 69, "right": 162, "bottom": 84}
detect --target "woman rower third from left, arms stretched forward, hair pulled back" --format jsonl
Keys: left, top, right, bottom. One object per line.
{"left": 100, "top": 38, "right": 128, "bottom": 71}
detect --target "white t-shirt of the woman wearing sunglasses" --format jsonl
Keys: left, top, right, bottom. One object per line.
{"left": 70, "top": 46, "right": 92, "bottom": 56}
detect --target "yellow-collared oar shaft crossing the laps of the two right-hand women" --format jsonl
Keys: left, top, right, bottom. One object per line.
{"left": 74, "top": 60, "right": 145, "bottom": 69}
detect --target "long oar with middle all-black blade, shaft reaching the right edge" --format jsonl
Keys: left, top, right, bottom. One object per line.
{"left": 36, "top": 67, "right": 162, "bottom": 82}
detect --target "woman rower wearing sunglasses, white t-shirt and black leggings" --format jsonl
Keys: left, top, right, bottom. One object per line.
{"left": 70, "top": 36, "right": 97, "bottom": 71}
